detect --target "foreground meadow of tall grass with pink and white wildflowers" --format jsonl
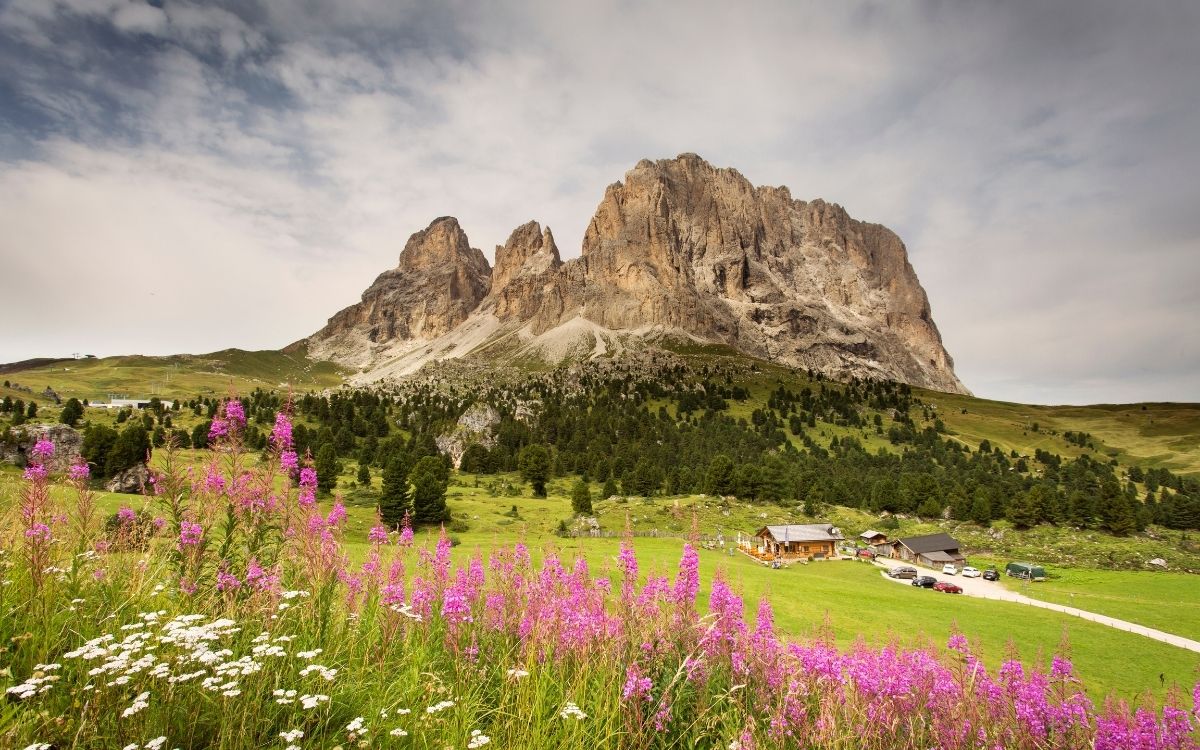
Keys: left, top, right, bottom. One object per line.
{"left": 0, "top": 401, "right": 1200, "bottom": 750}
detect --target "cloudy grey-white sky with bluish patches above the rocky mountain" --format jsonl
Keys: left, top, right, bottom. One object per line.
{"left": 0, "top": 0, "right": 1200, "bottom": 403}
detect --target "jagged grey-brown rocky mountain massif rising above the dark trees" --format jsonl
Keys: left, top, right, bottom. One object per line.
{"left": 298, "top": 154, "right": 967, "bottom": 394}
